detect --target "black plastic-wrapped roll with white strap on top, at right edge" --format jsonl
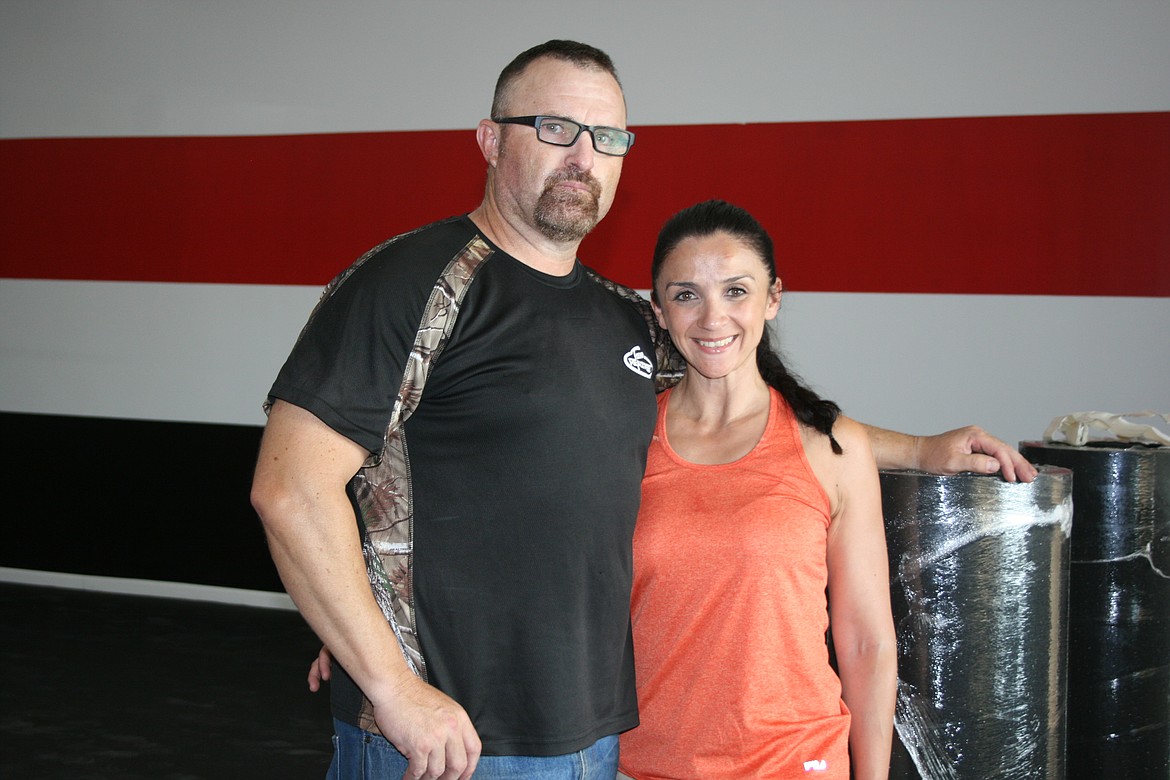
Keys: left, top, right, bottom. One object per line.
{"left": 1020, "top": 442, "right": 1170, "bottom": 780}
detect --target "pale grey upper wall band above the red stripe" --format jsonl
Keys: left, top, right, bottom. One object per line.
{"left": 0, "top": 0, "right": 1170, "bottom": 138}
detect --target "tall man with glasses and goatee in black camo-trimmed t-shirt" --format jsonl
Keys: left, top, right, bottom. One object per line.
{"left": 253, "top": 41, "right": 1031, "bottom": 778}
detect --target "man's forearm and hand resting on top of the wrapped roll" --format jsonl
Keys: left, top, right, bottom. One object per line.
{"left": 866, "top": 426, "right": 1037, "bottom": 482}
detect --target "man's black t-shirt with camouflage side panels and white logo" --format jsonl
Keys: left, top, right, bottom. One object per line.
{"left": 271, "top": 218, "right": 655, "bottom": 755}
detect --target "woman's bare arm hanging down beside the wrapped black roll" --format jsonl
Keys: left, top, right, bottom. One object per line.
{"left": 818, "top": 417, "right": 897, "bottom": 780}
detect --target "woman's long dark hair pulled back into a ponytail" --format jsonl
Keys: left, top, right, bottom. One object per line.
{"left": 651, "top": 200, "right": 841, "bottom": 455}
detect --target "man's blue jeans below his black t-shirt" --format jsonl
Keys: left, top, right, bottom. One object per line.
{"left": 325, "top": 718, "right": 618, "bottom": 780}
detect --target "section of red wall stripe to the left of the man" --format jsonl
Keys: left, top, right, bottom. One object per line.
{"left": 0, "top": 131, "right": 483, "bottom": 284}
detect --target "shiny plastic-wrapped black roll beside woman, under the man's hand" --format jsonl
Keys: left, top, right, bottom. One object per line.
{"left": 881, "top": 467, "right": 1073, "bottom": 780}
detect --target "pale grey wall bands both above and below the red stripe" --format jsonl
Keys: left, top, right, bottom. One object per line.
{"left": 0, "top": 0, "right": 1170, "bottom": 442}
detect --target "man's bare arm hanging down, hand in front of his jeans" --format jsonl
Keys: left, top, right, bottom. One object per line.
{"left": 252, "top": 401, "right": 480, "bottom": 780}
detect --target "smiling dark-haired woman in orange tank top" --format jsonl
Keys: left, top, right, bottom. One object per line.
{"left": 621, "top": 201, "right": 896, "bottom": 780}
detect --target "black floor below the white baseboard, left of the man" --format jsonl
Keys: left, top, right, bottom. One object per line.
{"left": 0, "top": 584, "right": 332, "bottom": 780}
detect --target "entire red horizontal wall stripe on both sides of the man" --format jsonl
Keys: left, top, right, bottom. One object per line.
{"left": 0, "top": 112, "right": 1170, "bottom": 297}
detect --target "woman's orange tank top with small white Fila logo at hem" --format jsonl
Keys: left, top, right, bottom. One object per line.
{"left": 621, "top": 389, "right": 849, "bottom": 780}
